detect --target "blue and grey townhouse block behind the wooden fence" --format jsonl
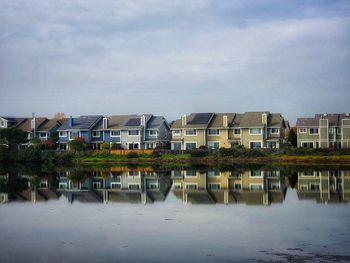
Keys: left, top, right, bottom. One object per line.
{"left": 58, "top": 114, "right": 170, "bottom": 149}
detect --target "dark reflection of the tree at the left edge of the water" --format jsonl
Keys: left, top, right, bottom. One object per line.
{"left": 0, "top": 175, "right": 28, "bottom": 197}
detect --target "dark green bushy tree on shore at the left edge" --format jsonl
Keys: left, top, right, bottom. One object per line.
{"left": 0, "top": 128, "right": 28, "bottom": 150}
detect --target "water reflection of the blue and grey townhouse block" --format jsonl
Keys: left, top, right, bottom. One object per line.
{"left": 59, "top": 170, "right": 171, "bottom": 204}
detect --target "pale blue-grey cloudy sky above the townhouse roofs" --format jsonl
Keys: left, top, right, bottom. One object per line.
{"left": 0, "top": 0, "right": 350, "bottom": 125}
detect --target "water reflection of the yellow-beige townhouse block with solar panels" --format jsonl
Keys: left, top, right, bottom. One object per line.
{"left": 172, "top": 170, "right": 286, "bottom": 205}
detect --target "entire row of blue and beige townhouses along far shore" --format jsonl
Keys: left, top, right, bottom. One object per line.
{"left": 0, "top": 111, "right": 350, "bottom": 150}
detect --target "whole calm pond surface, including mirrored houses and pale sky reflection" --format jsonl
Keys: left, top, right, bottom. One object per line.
{"left": 0, "top": 165, "right": 350, "bottom": 262}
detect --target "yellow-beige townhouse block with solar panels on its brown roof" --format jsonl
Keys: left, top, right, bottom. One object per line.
{"left": 171, "top": 112, "right": 289, "bottom": 150}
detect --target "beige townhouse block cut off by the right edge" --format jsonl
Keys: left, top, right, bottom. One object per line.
{"left": 296, "top": 113, "right": 350, "bottom": 148}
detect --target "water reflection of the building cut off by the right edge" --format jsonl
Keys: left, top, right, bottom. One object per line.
{"left": 298, "top": 170, "right": 350, "bottom": 203}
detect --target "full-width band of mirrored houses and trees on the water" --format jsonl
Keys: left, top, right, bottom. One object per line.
{"left": 0, "top": 167, "right": 350, "bottom": 206}
